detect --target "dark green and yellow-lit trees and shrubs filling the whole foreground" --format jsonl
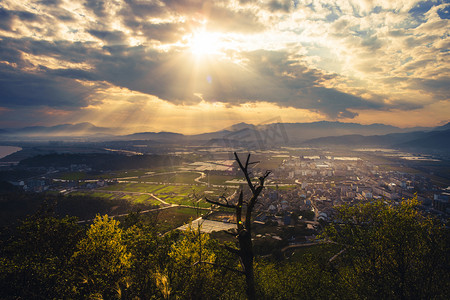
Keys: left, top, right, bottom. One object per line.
{"left": 0, "top": 200, "right": 450, "bottom": 299}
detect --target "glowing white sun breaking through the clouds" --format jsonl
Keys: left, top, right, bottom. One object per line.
{"left": 189, "top": 31, "right": 223, "bottom": 57}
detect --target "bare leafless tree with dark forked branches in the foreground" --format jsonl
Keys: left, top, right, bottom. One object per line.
{"left": 206, "top": 152, "right": 271, "bottom": 300}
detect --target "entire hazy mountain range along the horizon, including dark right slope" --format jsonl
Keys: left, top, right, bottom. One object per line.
{"left": 0, "top": 121, "right": 450, "bottom": 152}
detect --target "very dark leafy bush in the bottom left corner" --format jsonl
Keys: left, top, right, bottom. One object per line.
{"left": 0, "top": 212, "right": 82, "bottom": 299}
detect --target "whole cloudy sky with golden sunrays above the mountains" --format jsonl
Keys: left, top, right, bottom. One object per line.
{"left": 0, "top": 0, "right": 450, "bottom": 134}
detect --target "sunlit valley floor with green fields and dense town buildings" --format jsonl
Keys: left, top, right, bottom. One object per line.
{"left": 3, "top": 147, "right": 450, "bottom": 238}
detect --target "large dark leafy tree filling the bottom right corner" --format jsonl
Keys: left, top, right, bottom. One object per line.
{"left": 323, "top": 199, "right": 450, "bottom": 299}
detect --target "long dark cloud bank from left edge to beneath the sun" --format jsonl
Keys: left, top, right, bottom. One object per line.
{"left": 0, "top": 28, "right": 382, "bottom": 118}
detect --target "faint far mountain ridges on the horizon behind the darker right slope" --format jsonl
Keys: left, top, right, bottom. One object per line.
{"left": 0, "top": 121, "right": 440, "bottom": 148}
